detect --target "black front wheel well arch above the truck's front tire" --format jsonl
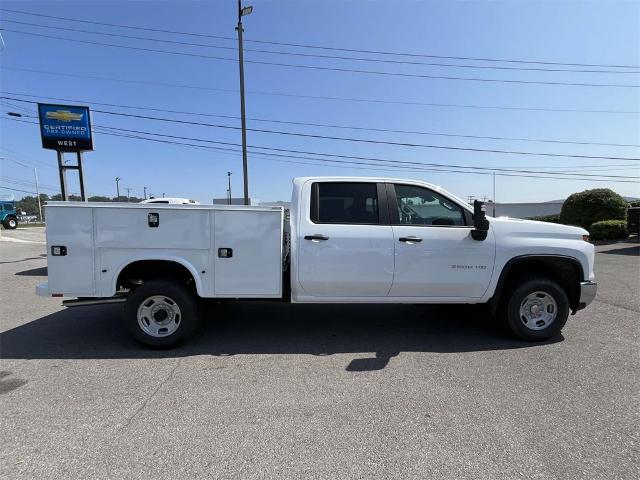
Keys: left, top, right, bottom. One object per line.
{"left": 489, "top": 256, "right": 583, "bottom": 311}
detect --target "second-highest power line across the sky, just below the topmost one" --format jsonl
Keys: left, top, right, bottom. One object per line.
{"left": 2, "top": 18, "right": 640, "bottom": 74}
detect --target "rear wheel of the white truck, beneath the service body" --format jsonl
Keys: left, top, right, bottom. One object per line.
{"left": 122, "top": 279, "right": 200, "bottom": 348}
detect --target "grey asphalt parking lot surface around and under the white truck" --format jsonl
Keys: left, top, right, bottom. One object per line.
{"left": 0, "top": 229, "right": 640, "bottom": 480}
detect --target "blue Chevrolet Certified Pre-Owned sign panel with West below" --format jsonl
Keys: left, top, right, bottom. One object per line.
{"left": 38, "top": 103, "right": 93, "bottom": 152}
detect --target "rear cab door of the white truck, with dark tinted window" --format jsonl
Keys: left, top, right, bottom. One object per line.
{"left": 296, "top": 181, "right": 394, "bottom": 297}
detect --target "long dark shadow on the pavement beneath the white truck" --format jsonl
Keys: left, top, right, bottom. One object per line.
{"left": 0, "top": 302, "right": 563, "bottom": 371}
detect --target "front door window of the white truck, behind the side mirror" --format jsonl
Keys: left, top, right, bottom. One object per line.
{"left": 395, "top": 185, "right": 465, "bottom": 226}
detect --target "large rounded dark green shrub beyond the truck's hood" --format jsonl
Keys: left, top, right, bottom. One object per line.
{"left": 560, "top": 188, "right": 627, "bottom": 229}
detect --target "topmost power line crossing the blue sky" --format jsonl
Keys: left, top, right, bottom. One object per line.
{"left": 0, "top": 8, "right": 639, "bottom": 68}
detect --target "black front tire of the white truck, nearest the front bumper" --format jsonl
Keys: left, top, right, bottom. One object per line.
{"left": 500, "top": 277, "right": 569, "bottom": 341}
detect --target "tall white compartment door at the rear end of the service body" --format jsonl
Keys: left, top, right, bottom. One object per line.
{"left": 46, "top": 205, "right": 95, "bottom": 297}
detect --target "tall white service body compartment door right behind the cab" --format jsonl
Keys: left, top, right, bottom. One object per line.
{"left": 212, "top": 209, "right": 283, "bottom": 298}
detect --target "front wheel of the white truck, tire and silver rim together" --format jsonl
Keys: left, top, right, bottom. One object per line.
{"left": 502, "top": 278, "right": 569, "bottom": 341}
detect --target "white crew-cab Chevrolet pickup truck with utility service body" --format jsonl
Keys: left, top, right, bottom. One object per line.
{"left": 37, "top": 177, "right": 597, "bottom": 347}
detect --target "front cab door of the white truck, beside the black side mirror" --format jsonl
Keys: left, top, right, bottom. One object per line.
{"left": 387, "top": 184, "right": 495, "bottom": 299}
